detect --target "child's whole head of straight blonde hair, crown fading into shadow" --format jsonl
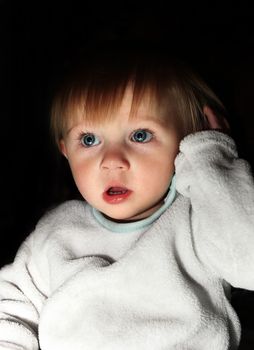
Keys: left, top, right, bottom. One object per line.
{"left": 51, "top": 53, "right": 225, "bottom": 144}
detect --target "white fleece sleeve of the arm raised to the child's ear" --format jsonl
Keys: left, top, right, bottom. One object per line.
{"left": 175, "top": 130, "right": 254, "bottom": 290}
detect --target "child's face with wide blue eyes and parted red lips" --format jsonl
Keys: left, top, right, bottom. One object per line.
{"left": 61, "top": 89, "right": 180, "bottom": 221}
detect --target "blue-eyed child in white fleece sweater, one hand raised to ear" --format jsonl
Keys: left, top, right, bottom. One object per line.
{"left": 0, "top": 50, "right": 254, "bottom": 350}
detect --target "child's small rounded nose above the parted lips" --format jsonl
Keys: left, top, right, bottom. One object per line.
{"left": 101, "top": 147, "right": 130, "bottom": 171}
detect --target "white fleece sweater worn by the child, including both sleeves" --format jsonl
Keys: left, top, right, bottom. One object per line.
{"left": 0, "top": 131, "right": 254, "bottom": 350}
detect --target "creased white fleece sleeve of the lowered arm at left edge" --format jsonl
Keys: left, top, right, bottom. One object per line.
{"left": 0, "top": 236, "right": 45, "bottom": 350}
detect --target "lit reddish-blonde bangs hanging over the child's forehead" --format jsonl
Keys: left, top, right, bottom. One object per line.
{"left": 62, "top": 78, "right": 158, "bottom": 129}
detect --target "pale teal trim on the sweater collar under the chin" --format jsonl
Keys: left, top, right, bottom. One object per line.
{"left": 92, "top": 175, "right": 176, "bottom": 233}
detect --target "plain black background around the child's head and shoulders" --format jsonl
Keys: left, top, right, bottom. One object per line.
{"left": 0, "top": 0, "right": 254, "bottom": 344}
